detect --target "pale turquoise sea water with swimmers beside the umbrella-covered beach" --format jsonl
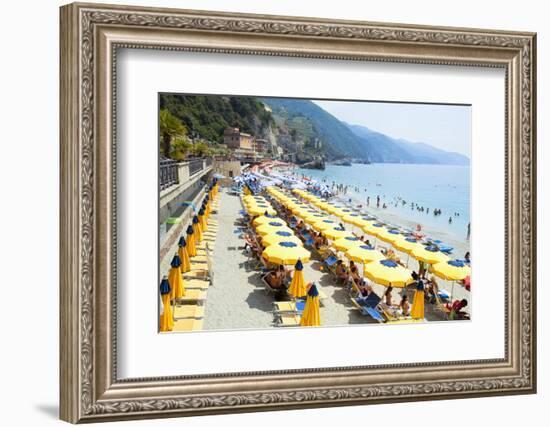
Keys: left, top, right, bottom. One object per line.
{"left": 295, "top": 163, "right": 470, "bottom": 240}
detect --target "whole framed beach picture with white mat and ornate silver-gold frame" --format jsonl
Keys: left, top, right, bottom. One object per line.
{"left": 60, "top": 4, "right": 536, "bottom": 423}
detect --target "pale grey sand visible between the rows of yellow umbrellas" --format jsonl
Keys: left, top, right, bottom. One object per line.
{"left": 203, "top": 189, "right": 469, "bottom": 330}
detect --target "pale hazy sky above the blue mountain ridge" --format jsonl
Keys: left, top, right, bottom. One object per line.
{"left": 314, "top": 101, "right": 471, "bottom": 157}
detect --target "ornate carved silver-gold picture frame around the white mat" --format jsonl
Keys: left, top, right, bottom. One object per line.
{"left": 60, "top": 4, "right": 536, "bottom": 423}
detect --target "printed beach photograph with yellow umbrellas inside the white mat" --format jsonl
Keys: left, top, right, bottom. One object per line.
{"left": 157, "top": 93, "right": 472, "bottom": 333}
